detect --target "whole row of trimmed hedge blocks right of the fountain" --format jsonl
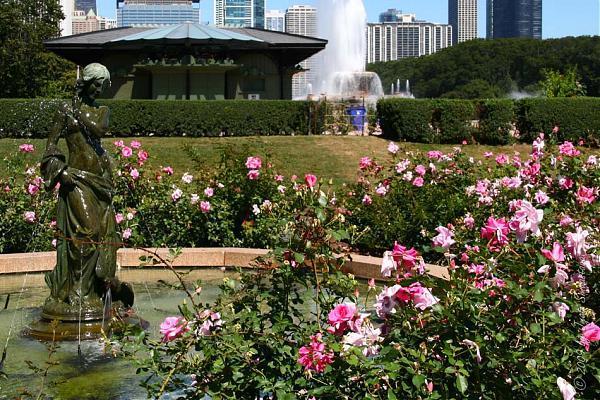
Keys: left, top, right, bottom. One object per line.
{"left": 377, "top": 97, "right": 600, "bottom": 146}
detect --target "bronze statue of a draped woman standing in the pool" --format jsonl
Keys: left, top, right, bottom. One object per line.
{"left": 41, "top": 63, "right": 133, "bottom": 321}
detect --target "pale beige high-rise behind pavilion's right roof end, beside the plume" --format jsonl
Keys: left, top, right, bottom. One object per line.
{"left": 285, "top": 5, "right": 317, "bottom": 98}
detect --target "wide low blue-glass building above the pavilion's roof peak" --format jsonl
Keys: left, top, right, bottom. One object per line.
{"left": 117, "top": 0, "right": 200, "bottom": 28}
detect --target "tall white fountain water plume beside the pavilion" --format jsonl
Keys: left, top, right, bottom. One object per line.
{"left": 314, "top": 0, "right": 383, "bottom": 99}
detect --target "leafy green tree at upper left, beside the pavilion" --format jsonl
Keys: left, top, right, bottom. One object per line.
{"left": 0, "top": 0, "right": 74, "bottom": 98}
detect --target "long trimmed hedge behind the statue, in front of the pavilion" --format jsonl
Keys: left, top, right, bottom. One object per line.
{"left": 0, "top": 99, "right": 322, "bottom": 138}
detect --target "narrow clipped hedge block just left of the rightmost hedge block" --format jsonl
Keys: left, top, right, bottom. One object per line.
{"left": 475, "top": 99, "right": 515, "bottom": 145}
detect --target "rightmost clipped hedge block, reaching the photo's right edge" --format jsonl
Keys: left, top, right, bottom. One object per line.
{"left": 517, "top": 97, "right": 600, "bottom": 146}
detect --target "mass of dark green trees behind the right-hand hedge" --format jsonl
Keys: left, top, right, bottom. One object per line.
{"left": 367, "top": 36, "right": 600, "bottom": 98}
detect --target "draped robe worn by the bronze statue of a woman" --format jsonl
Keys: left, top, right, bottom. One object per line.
{"left": 41, "top": 109, "right": 118, "bottom": 304}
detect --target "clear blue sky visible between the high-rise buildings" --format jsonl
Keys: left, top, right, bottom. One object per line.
{"left": 96, "top": 0, "right": 600, "bottom": 38}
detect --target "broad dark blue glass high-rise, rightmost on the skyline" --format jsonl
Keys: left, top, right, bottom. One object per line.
{"left": 487, "top": 0, "right": 542, "bottom": 39}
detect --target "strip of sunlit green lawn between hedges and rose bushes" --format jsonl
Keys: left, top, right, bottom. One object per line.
{"left": 0, "top": 136, "right": 580, "bottom": 185}
